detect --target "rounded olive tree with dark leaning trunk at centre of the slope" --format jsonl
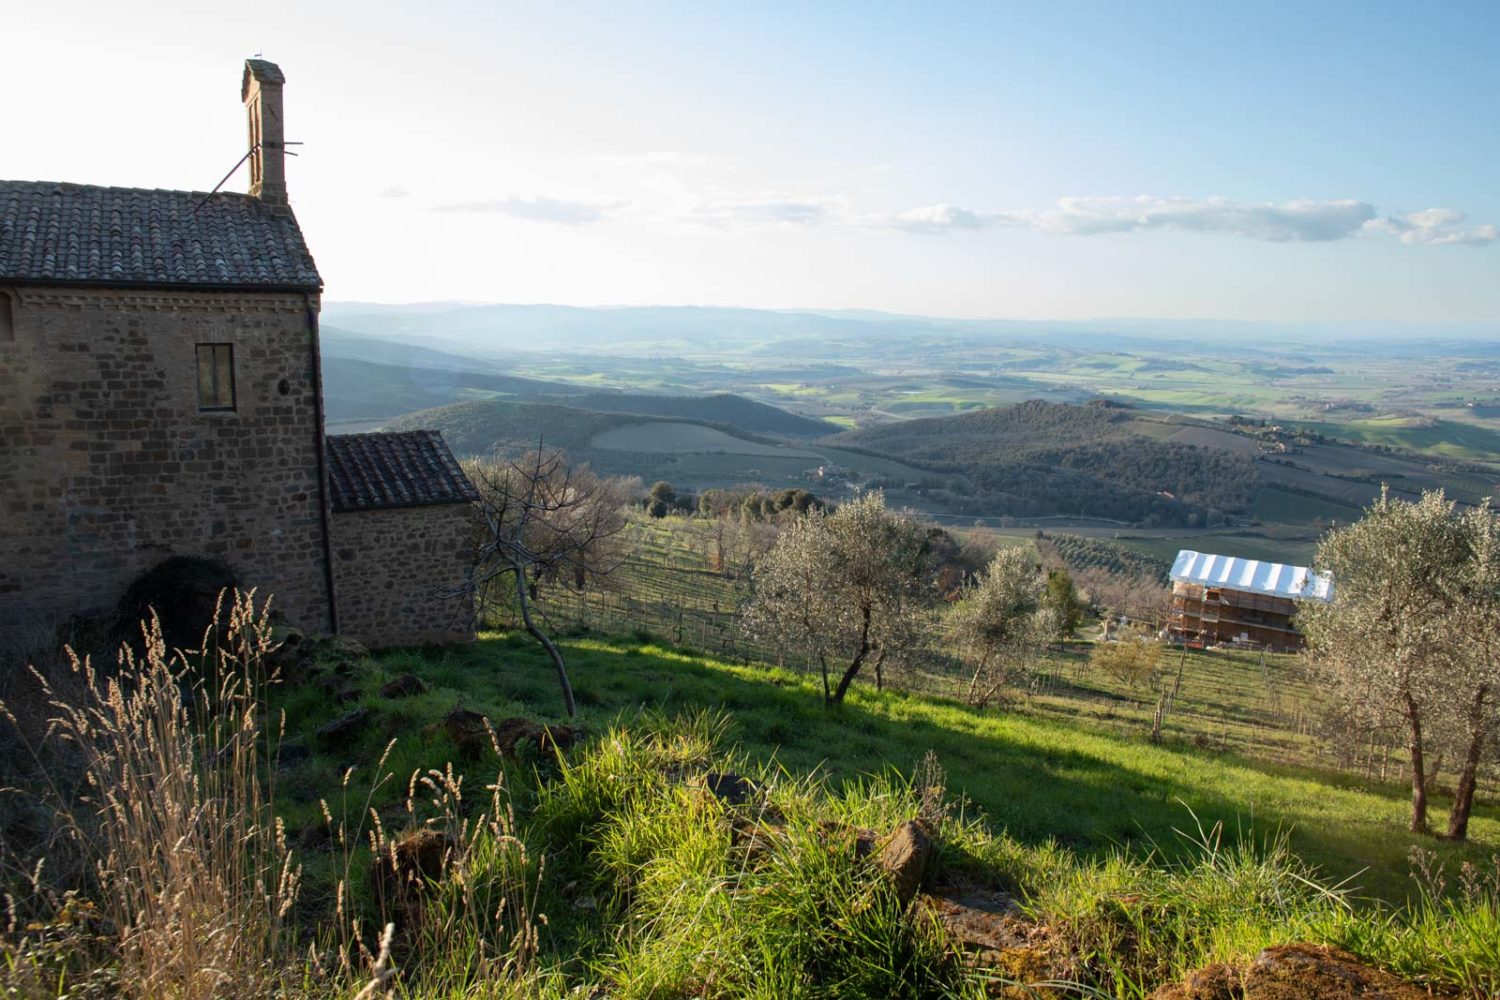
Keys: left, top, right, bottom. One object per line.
{"left": 743, "top": 490, "right": 932, "bottom": 705}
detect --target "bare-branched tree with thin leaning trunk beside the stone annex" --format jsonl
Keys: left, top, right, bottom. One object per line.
{"left": 465, "top": 450, "right": 629, "bottom": 715}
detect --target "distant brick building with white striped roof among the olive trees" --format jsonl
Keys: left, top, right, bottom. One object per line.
{"left": 1167, "top": 549, "right": 1334, "bottom": 649}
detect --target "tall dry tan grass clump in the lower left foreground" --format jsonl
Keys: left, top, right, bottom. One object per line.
{"left": 0, "top": 594, "right": 300, "bottom": 1000}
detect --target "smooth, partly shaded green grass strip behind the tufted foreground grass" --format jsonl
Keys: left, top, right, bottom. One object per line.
{"left": 279, "top": 634, "right": 1500, "bottom": 917}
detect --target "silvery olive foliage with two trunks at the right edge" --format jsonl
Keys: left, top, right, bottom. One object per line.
{"left": 1298, "top": 490, "right": 1500, "bottom": 838}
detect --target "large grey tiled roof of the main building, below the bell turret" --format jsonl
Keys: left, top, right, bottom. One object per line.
{"left": 0, "top": 180, "right": 323, "bottom": 289}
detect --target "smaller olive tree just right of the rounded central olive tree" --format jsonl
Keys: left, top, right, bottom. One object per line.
{"left": 947, "top": 549, "right": 1059, "bottom": 708}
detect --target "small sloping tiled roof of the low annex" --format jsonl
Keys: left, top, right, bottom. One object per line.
{"left": 327, "top": 430, "right": 479, "bottom": 511}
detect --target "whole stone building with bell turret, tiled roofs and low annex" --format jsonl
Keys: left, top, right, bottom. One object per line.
{"left": 0, "top": 60, "right": 476, "bottom": 645}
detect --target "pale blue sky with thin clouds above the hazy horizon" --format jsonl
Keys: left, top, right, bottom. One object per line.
{"left": 0, "top": 0, "right": 1500, "bottom": 322}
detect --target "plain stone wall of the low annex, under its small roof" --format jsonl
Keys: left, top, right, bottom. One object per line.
{"left": 333, "top": 504, "right": 474, "bottom": 648}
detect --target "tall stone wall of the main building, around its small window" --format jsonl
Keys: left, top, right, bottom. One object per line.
{"left": 0, "top": 286, "right": 329, "bottom": 630}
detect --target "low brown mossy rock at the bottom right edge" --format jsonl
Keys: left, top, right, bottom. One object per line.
{"left": 1152, "top": 943, "right": 1430, "bottom": 1000}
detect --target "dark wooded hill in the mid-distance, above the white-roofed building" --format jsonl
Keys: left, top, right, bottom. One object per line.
{"left": 836, "top": 400, "right": 1259, "bottom": 523}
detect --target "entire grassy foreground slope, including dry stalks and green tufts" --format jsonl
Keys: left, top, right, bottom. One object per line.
{"left": 14, "top": 606, "right": 1500, "bottom": 1000}
